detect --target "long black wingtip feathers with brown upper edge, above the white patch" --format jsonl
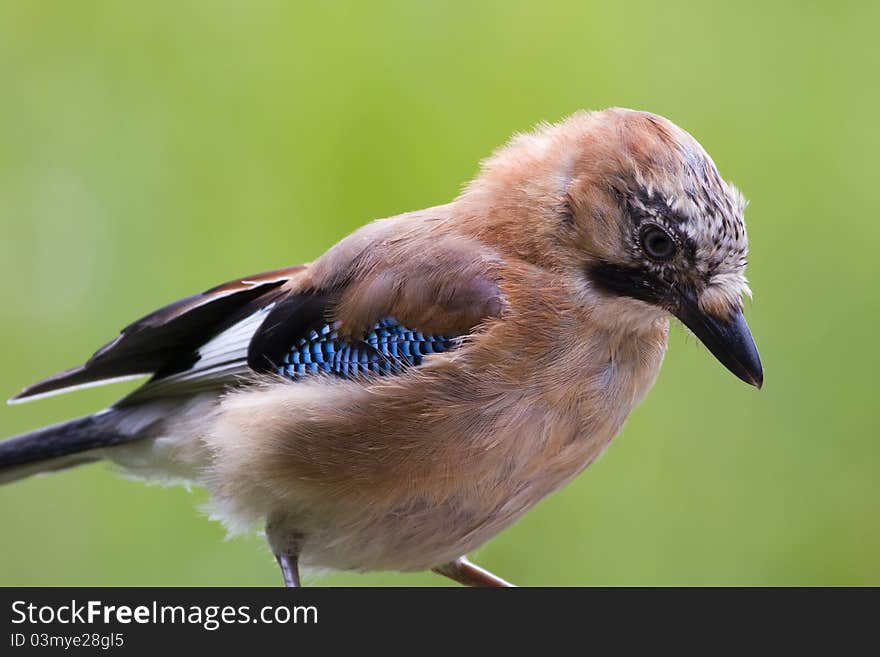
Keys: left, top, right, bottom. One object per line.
{"left": 10, "top": 265, "right": 306, "bottom": 402}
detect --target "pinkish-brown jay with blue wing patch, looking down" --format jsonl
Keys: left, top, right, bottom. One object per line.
{"left": 0, "top": 108, "right": 764, "bottom": 587}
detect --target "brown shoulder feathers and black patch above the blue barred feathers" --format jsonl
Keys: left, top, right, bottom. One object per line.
{"left": 247, "top": 223, "right": 505, "bottom": 372}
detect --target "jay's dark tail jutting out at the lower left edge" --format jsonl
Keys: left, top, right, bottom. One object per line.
{"left": 0, "top": 408, "right": 139, "bottom": 484}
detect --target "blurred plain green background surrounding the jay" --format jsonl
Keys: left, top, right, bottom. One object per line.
{"left": 0, "top": 0, "right": 880, "bottom": 585}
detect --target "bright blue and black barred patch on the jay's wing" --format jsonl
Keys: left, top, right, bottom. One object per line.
{"left": 275, "top": 317, "right": 458, "bottom": 380}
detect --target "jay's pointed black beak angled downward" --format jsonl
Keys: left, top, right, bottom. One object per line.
{"left": 673, "top": 292, "right": 764, "bottom": 388}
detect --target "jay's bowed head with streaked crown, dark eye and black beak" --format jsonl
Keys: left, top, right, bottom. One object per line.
{"left": 462, "top": 109, "right": 763, "bottom": 387}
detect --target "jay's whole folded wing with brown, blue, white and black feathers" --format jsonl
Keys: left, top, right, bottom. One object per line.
{"left": 11, "top": 229, "right": 503, "bottom": 404}
